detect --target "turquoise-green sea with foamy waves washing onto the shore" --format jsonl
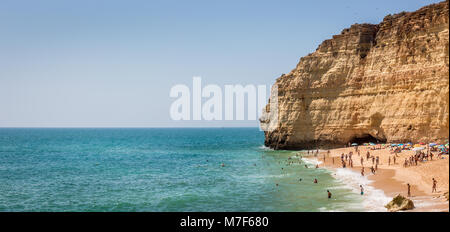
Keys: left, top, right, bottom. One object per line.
{"left": 0, "top": 128, "right": 372, "bottom": 211}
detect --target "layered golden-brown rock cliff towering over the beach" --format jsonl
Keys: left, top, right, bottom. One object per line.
{"left": 265, "top": 1, "right": 449, "bottom": 149}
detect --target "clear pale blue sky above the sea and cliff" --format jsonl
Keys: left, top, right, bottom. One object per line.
{"left": 0, "top": 0, "right": 439, "bottom": 127}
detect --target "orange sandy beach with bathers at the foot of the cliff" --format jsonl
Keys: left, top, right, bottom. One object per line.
{"left": 313, "top": 146, "right": 449, "bottom": 212}
